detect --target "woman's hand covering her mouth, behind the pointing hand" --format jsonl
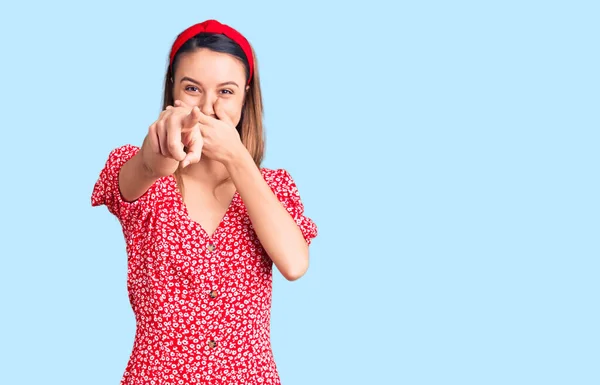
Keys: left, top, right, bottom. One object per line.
{"left": 174, "top": 100, "right": 247, "bottom": 165}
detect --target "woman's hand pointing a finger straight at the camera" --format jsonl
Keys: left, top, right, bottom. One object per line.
{"left": 143, "top": 106, "right": 203, "bottom": 177}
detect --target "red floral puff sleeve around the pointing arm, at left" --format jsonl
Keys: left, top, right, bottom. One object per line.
{"left": 92, "top": 145, "right": 155, "bottom": 225}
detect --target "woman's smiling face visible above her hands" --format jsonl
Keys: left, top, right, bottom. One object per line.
{"left": 173, "top": 48, "right": 248, "bottom": 126}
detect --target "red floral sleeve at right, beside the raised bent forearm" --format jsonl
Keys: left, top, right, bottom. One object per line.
{"left": 275, "top": 169, "right": 317, "bottom": 245}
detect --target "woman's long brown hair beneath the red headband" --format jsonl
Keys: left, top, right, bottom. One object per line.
{"left": 162, "top": 33, "right": 265, "bottom": 194}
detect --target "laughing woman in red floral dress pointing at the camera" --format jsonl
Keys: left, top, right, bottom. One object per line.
{"left": 92, "top": 20, "right": 317, "bottom": 384}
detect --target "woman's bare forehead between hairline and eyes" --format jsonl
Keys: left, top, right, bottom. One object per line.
{"left": 175, "top": 48, "right": 246, "bottom": 83}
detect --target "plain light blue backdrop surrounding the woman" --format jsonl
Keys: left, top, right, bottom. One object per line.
{"left": 0, "top": 1, "right": 600, "bottom": 385}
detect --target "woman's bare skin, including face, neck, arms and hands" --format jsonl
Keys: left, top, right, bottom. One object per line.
{"left": 119, "top": 49, "right": 309, "bottom": 281}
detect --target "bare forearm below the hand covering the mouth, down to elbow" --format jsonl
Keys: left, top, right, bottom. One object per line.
{"left": 225, "top": 151, "right": 309, "bottom": 281}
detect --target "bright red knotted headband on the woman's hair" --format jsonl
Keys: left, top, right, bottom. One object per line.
{"left": 169, "top": 20, "right": 254, "bottom": 83}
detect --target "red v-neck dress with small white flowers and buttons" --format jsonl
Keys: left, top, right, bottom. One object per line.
{"left": 91, "top": 145, "right": 317, "bottom": 385}
